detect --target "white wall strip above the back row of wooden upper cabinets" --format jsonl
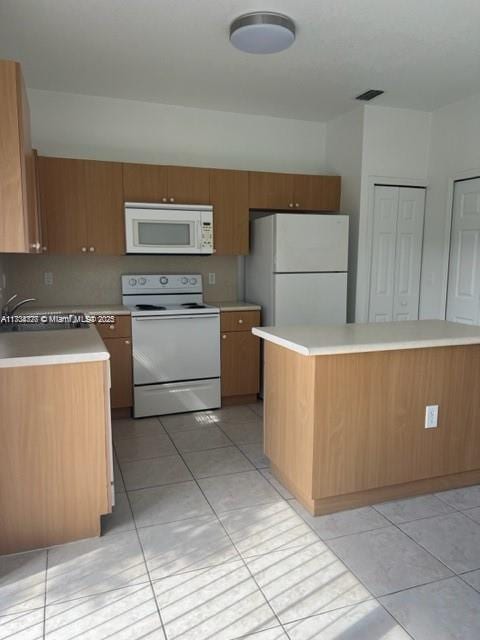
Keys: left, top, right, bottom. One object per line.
{"left": 28, "top": 90, "right": 326, "bottom": 173}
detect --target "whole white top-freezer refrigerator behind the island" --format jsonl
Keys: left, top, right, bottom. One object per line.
{"left": 245, "top": 213, "right": 348, "bottom": 326}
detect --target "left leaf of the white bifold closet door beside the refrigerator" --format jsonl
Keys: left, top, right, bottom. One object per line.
{"left": 368, "top": 187, "right": 400, "bottom": 322}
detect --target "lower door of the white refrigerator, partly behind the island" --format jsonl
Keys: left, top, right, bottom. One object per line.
{"left": 274, "top": 273, "right": 347, "bottom": 326}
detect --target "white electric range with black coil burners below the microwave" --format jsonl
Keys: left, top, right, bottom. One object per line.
{"left": 122, "top": 274, "right": 221, "bottom": 418}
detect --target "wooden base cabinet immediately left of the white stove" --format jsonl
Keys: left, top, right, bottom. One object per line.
{"left": 97, "top": 315, "right": 133, "bottom": 415}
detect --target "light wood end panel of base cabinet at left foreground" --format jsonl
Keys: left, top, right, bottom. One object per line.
{"left": 0, "top": 361, "right": 112, "bottom": 555}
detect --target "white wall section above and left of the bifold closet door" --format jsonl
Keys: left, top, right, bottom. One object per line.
{"left": 355, "top": 105, "right": 431, "bottom": 322}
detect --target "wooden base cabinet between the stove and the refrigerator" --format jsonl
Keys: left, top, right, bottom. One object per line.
{"left": 220, "top": 311, "right": 260, "bottom": 404}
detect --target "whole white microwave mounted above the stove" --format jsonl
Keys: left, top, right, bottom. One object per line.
{"left": 125, "top": 202, "right": 214, "bottom": 254}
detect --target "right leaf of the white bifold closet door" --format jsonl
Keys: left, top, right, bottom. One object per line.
{"left": 393, "top": 187, "right": 425, "bottom": 320}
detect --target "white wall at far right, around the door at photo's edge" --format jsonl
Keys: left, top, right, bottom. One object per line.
{"left": 420, "top": 95, "right": 480, "bottom": 318}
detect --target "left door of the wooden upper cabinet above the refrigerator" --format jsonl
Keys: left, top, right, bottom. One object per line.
{"left": 249, "top": 171, "right": 294, "bottom": 210}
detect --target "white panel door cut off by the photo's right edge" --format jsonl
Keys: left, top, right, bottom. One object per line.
{"left": 447, "top": 178, "right": 480, "bottom": 324}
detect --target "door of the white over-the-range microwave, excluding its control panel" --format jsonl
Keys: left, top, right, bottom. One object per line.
{"left": 125, "top": 206, "right": 202, "bottom": 254}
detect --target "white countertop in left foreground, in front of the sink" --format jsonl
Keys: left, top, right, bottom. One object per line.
{"left": 0, "top": 325, "right": 110, "bottom": 368}
